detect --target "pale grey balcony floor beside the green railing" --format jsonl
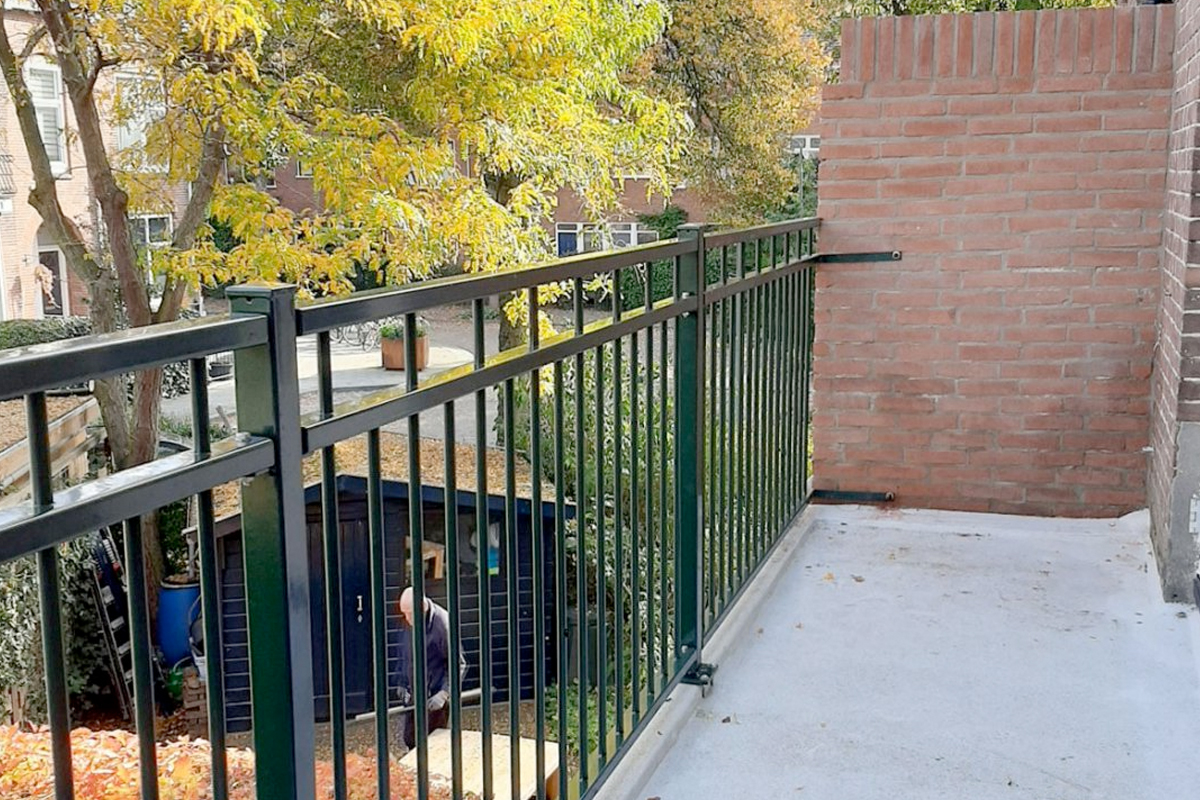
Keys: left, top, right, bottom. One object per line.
{"left": 601, "top": 506, "right": 1200, "bottom": 800}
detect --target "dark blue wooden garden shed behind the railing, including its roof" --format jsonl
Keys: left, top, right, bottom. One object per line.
{"left": 208, "top": 432, "right": 564, "bottom": 732}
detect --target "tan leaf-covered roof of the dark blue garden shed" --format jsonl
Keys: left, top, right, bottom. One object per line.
{"left": 212, "top": 431, "right": 553, "bottom": 519}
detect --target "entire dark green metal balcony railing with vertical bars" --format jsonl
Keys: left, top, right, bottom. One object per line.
{"left": 0, "top": 219, "right": 817, "bottom": 800}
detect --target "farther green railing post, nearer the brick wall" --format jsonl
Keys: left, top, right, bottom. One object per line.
{"left": 674, "top": 224, "right": 714, "bottom": 691}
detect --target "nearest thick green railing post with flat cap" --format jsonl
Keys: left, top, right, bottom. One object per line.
{"left": 227, "top": 284, "right": 316, "bottom": 800}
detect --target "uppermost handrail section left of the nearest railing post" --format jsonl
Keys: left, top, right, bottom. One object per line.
{"left": 0, "top": 315, "right": 266, "bottom": 401}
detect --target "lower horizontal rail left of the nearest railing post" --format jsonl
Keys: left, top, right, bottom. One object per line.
{"left": 0, "top": 434, "right": 275, "bottom": 563}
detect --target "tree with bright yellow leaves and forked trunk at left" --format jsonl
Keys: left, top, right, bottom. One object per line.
{"left": 0, "top": 0, "right": 686, "bottom": 582}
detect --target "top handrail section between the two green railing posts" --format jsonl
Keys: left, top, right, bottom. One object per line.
{"left": 296, "top": 239, "right": 696, "bottom": 336}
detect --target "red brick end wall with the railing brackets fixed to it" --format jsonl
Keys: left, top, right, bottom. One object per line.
{"left": 814, "top": 6, "right": 1174, "bottom": 516}
